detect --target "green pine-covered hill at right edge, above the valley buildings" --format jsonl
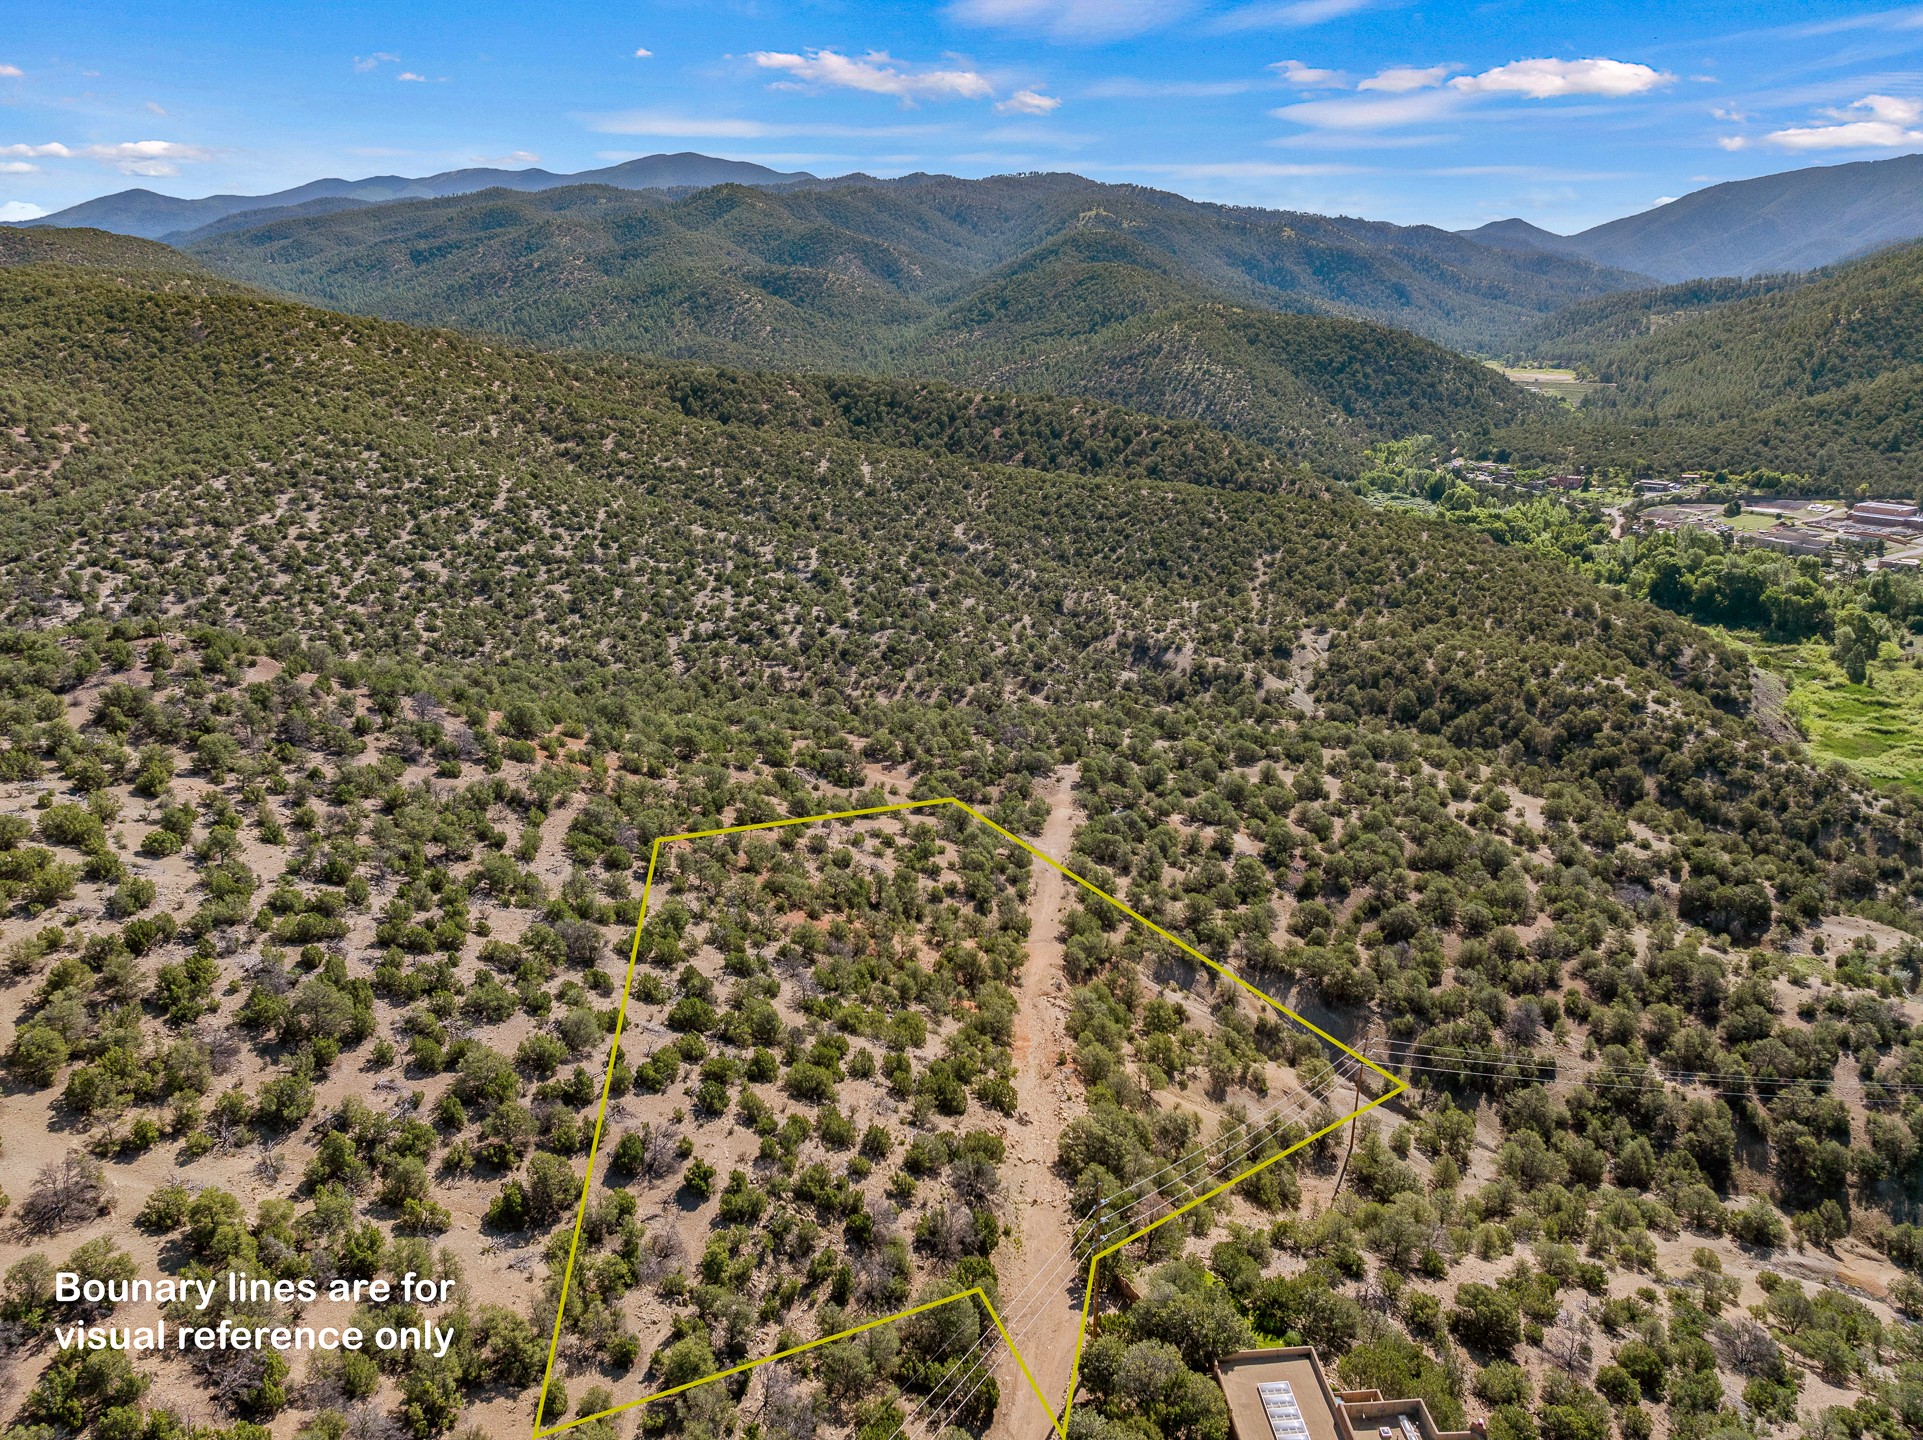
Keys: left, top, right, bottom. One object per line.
{"left": 1500, "top": 246, "right": 1923, "bottom": 494}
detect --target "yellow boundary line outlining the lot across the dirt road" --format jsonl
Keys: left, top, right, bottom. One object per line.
{"left": 531, "top": 796, "right": 1408, "bottom": 1440}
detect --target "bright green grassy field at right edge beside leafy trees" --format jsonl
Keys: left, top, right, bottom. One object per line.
{"left": 1725, "top": 631, "right": 1923, "bottom": 790}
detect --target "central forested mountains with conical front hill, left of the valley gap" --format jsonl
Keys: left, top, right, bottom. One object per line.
{"left": 165, "top": 177, "right": 1584, "bottom": 473}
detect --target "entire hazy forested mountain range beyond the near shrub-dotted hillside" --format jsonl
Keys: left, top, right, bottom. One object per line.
{"left": 22, "top": 154, "right": 1923, "bottom": 488}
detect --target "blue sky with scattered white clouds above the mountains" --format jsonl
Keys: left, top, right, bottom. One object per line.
{"left": 0, "top": 0, "right": 1923, "bottom": 231}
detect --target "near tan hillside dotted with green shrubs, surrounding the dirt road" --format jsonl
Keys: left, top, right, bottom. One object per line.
{"left": 0, "top": 265, "right": 1923, "bottom": 1440}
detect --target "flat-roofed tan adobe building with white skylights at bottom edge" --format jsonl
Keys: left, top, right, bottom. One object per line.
{"left": 1215, "top": 1346, "right": 1485, "bottom": 1440}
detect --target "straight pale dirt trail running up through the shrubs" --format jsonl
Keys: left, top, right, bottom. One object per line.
{"left": 988, "top": 769, "right": 1081, "bottom": 1440}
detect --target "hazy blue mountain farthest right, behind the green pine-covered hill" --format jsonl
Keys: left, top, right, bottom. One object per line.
{"left": 1461, "top": 156, "right": 1923, "bottom": 281}
